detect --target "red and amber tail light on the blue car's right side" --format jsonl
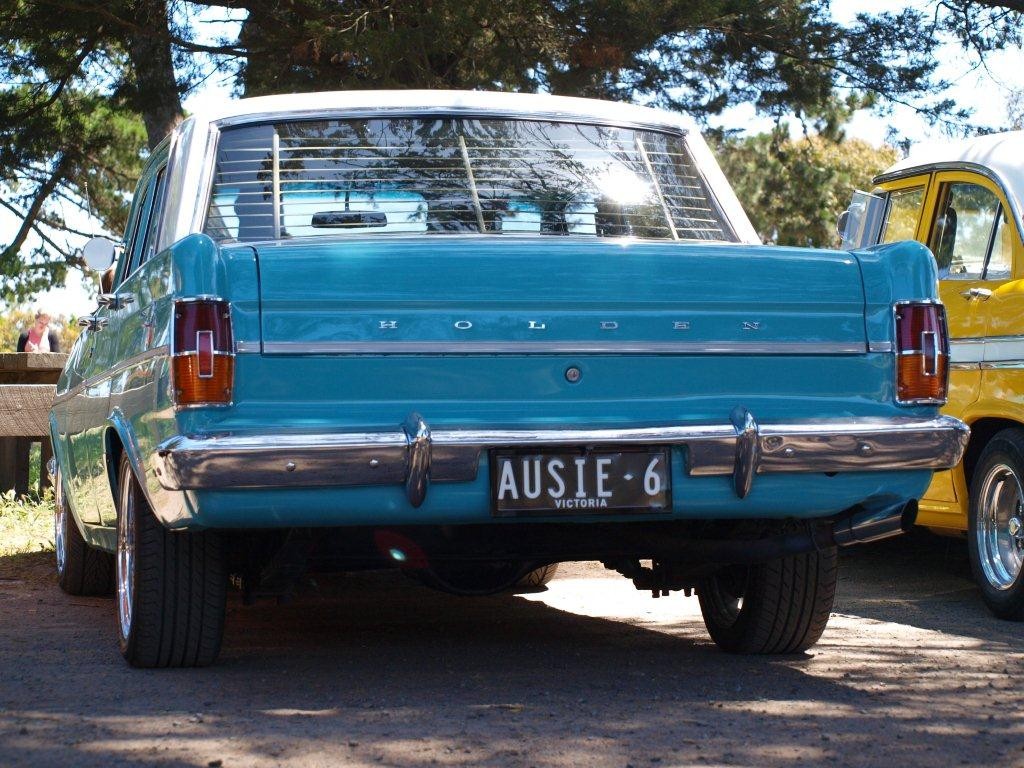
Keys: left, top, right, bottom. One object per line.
{"left": 895, "top": 302, "right": 949, "bottom": 406}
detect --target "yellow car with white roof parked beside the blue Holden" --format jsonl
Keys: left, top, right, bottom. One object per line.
{"left": 841, "top": 131, "right": 1024, "bottom": 621}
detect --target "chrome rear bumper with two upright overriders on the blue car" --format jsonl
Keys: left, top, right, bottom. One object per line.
{"left": 152, "top": 408, "right": 970, "bottom": 507}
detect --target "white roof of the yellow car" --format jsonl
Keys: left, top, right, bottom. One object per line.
{"left": 874, "top": 131, "right": 1024, "bottom": 189}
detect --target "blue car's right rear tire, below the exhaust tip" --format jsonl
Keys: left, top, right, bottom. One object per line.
{"left": 697, "top": 547, "right": 839, "bottom": 653}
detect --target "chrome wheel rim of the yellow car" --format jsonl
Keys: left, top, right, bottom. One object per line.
{"left": 975, "top": 464, "right": 1024, "bottom": 590}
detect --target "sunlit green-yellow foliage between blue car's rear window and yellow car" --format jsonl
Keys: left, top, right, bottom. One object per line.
{"left": 718, "top": 129, "right": 899, "bottom": 248}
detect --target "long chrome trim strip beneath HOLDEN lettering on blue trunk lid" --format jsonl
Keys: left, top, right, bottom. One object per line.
{"left": 263, "top": 341, "right": 866, "bottom": 355}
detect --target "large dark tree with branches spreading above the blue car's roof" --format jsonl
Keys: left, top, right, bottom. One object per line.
{"left": 0, "top": 0, "right": 1024, "bottom": 299}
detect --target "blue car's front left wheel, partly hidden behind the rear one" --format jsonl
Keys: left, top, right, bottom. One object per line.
{"left": 53, "top": 471, "right": 114, "bottom": 595}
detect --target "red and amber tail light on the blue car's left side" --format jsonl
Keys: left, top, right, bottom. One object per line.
{"left": 171, "top": 298, "right": 234, "bottom": 408}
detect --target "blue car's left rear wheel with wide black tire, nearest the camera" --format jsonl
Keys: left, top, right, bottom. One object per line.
{"left": 116, "top": 456, "right": 227, "bottom": 667}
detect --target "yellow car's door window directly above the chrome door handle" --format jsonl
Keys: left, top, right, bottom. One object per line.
{"left": 929, "top": 181, "right": 1009, "bottom": 280}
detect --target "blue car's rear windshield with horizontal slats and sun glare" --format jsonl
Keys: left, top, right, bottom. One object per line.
{"left": 206, "top": 118, "right": 735, "bottom": 241}
